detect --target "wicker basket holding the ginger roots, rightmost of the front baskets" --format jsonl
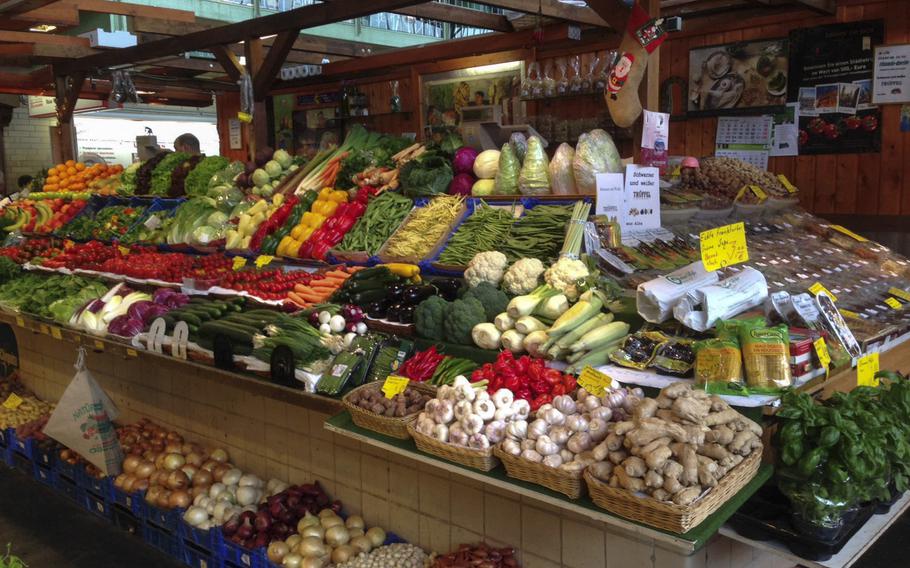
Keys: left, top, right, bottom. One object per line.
{"left": 584, "top": 452, "right": 761, "bottom": 534}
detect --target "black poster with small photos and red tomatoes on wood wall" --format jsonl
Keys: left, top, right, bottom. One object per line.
{"left": 788, "top": 20, "right": 884, "bottom": 154}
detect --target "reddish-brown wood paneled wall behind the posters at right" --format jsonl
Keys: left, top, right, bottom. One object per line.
{"left": 660, "top": 0, "right": 910, "bottom": 215}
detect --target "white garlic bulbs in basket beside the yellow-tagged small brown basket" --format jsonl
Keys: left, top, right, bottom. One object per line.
{"left": 415, "top": 376, "right": 531, "bottom": 450}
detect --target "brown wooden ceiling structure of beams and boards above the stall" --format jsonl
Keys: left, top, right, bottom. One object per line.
{"left": 0, "top": 0, "right": 835, "bottom": 158}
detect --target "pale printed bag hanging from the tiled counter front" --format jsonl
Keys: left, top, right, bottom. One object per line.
{"left": 44, "top": 348, "right": 123, "bottom": 475}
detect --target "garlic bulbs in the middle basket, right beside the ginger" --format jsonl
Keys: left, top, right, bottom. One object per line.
{"left": 501, "top": 388, "right": 644, "bottom": 474}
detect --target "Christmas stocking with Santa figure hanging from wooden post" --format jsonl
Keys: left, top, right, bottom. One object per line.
{"left": 604, "top": 4, "right": 667, "bottom": 128}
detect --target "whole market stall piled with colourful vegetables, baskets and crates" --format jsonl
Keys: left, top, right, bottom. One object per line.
{"left": 0, "top": 2, "right": 910, "bottom": 568}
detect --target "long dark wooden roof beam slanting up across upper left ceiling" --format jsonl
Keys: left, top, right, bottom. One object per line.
{"left": 61, "top": 0, "right": 428, "bottom": 71}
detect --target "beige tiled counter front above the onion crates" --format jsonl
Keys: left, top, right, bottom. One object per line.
{"left": 16, "top": 329, "right": 789, "bottom": 568}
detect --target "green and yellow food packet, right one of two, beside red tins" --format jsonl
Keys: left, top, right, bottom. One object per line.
{"left": 739, "top": 320, "right": 793, "bottom": 393}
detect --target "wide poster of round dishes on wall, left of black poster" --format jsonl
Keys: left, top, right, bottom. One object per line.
{"left": 687, "top": 39, "right": 789, "bottom": 116}
